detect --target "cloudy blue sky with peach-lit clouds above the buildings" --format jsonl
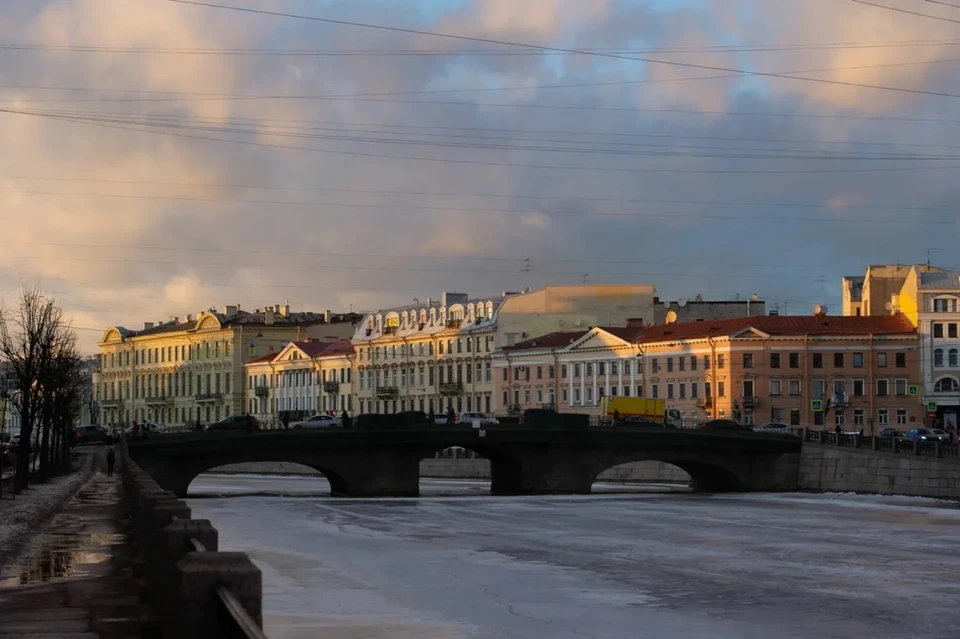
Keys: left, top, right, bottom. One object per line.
{"left": 0, "top": 0, "right": 960, "bottom": 352}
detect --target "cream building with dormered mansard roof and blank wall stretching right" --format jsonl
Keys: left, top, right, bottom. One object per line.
{"left": 353, "top": 285, "right": 654, "bottom": 413}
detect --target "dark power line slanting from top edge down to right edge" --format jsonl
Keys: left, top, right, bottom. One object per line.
{"left": 168, "top": 0, "right": 960, "bottom": 98}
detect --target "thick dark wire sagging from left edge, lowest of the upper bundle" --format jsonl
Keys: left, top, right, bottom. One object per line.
{"left": 7, "top": 108, "right": 960, "bottom": 175}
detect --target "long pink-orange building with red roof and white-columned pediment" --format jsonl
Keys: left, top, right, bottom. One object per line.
{"left": 494, "top": 315, "right": 923, "bottom": 432}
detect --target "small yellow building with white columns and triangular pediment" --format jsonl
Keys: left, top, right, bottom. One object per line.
{"left": 243, "top": 341, "right": 356, "bottom": 429}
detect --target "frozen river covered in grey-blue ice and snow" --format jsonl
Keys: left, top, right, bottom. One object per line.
{"left": 190, "top": 475, "right": 960, "bottom": 639}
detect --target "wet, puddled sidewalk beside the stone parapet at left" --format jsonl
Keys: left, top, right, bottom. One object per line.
{"left": 0, "top": 472, "right": 149, "bottom": 639}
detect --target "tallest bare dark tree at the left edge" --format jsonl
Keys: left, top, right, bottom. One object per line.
{"left": 0, "top": 286, "right": 79, "bottom": 490}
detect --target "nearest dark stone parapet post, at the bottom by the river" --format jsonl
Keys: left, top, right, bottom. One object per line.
{"left": 172, "top": 552, "right": 263, "bottom": 639}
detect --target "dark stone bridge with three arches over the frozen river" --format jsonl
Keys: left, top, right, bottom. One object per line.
{"left": 128, "top": 427, "right": 802, "bottom": 497}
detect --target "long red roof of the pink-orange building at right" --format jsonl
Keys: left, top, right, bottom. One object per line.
{"left": 638, "top": 315, "right": 916, "bottom": 343}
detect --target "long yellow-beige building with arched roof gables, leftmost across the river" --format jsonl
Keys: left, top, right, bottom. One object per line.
{"left": 94, "top": 304, "right": 360, "bottom": 426}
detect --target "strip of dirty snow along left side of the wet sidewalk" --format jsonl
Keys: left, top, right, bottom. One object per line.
{"left": 0, "top": 455, "right": 94, "bottom": 568}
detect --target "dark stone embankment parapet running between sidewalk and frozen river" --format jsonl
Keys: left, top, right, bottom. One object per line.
{"left": 119, "top": 442, "right": 265, "bottom": 639}
